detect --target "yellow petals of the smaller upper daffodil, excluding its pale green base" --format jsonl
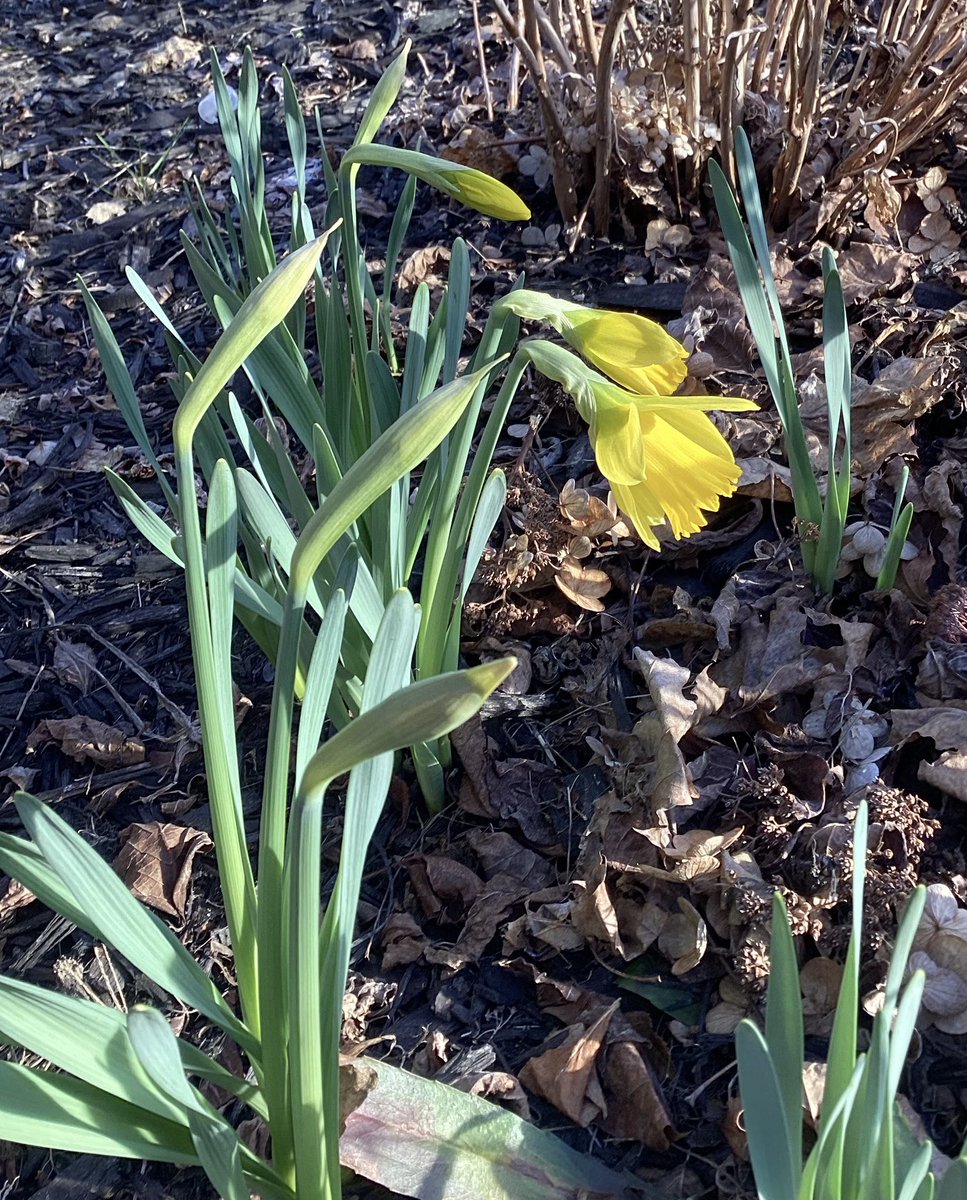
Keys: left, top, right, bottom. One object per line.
{"left": 560, "top": 305, "right": 689, "bottom": 396}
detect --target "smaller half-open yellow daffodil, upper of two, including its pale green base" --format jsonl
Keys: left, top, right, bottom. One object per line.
{"left": 498, "top": 288, "right": 689, "bottom": 396}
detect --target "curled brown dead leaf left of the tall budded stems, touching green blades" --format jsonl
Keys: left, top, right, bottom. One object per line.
{"left": 114, "top": 821, "right": 212, "bottom": 919}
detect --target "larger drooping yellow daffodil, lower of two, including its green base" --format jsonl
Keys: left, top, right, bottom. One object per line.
{"left": 523, "top": 340, "right": 756, "bottom": 550}
